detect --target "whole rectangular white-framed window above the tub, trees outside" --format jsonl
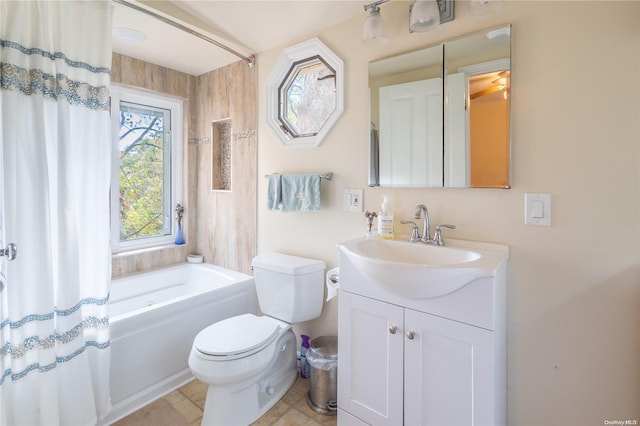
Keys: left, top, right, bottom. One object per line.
{"left": 111, "top": 86, "right": 182, "bottom": 252}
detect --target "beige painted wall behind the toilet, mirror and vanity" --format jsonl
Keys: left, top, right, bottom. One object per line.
{"left": 258, "top": 1, "right": 640, "bottom": 426}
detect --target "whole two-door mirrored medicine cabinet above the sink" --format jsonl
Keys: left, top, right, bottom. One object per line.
{"left": 369, "top": 25, "right": 511, "bottom": 188}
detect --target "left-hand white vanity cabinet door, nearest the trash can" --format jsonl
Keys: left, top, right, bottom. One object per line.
{"left": 338, "top": 291, "right": 404, "bottom": 426}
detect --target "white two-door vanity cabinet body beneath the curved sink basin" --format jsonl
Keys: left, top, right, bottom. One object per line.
{"left": 338, "top": 238, "right": 508, "bottom": 426}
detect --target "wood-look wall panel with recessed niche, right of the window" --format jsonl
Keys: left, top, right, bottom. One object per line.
{"left": 196, "top": 62, "right": 257, "bottom": 273}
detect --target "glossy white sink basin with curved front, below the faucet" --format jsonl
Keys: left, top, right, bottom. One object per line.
{"left": 338, "top": 238, "right": 507, "bottom": 299}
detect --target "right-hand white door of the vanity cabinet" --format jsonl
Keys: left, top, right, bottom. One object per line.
{"left": 404, "top": 309, "right": 494, "bottom": 426}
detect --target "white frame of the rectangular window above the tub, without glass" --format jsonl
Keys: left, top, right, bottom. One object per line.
{"left": 110, "top": 84, "right": 184, "bottom": 254}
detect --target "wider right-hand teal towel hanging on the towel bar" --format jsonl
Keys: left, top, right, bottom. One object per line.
{"left": 282, "top": 175, "right": 320, "bottom": 211}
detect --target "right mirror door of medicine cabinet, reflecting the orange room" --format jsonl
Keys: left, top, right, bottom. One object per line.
{"left": 444, "top": 25, "right": 511, "bottom": 188}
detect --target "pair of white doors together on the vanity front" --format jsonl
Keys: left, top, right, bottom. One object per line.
{"left": 338, "top": 292, "right": 494, "bottom": 426}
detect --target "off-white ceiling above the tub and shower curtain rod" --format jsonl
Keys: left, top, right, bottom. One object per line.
{"left": 113, "top": 0, "right": 366, "bottom": 75}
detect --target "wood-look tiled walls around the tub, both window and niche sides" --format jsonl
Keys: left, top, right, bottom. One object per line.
{"left": 111, "top": 53, "right": 257, "bottom": 278}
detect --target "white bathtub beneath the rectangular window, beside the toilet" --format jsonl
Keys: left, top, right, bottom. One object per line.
{"left": 101, "top": 263, "right": 258, "bottom": 424}
